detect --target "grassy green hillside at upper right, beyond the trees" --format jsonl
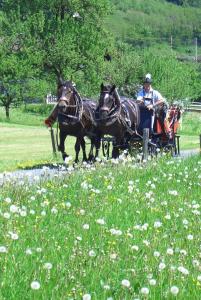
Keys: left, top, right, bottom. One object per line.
{"left": 107, "top": 0, "right": 201, "bottom": 54}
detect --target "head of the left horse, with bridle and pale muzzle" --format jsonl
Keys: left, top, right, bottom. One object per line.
{"left": 57, "top": 81, "right": 75, "bottom": 112}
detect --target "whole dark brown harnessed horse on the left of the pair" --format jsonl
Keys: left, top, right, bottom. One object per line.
{"left": 45, "top": 80, "right": 99, "bottom": 163}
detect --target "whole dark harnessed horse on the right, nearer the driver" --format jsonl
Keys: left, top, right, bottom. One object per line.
{"left": 95, "top": 83, "right": 139, "bottom": 158}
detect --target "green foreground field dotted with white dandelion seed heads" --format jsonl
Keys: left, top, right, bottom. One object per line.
{"left": 0, "top": 156, "right": 201, "bottom": 300}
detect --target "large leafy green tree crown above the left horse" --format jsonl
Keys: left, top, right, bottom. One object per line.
{"left": 2, "top": 0, "right": 109, "bottom": 95}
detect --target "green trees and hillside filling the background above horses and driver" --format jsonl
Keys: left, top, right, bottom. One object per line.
{"left": 0, "top": 0, "right": 201, "bottom": 115}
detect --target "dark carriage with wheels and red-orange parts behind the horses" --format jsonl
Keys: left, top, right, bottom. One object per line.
{"left": 101, "top": 105, "right": 180, "bottom": 159}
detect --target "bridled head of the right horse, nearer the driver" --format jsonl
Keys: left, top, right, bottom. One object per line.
{"left": 99, "top": 83, "right": 117, "bottom": 119}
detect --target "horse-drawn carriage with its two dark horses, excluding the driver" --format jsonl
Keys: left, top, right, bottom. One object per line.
{"left": 45, "top": 81, "right": 180, "bottom": 162}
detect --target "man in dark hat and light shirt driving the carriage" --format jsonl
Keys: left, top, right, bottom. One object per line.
{"left": 137, "top": 74, "right": 165, "bottom": 133}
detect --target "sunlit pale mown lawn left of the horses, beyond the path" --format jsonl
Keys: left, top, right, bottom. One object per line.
{"left": 0, "top": 123, "right": 75, "bottom": 171}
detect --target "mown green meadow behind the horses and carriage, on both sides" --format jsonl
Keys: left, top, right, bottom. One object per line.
{"left": 0, "top": 109, "right": 201, "bottom": 172}
